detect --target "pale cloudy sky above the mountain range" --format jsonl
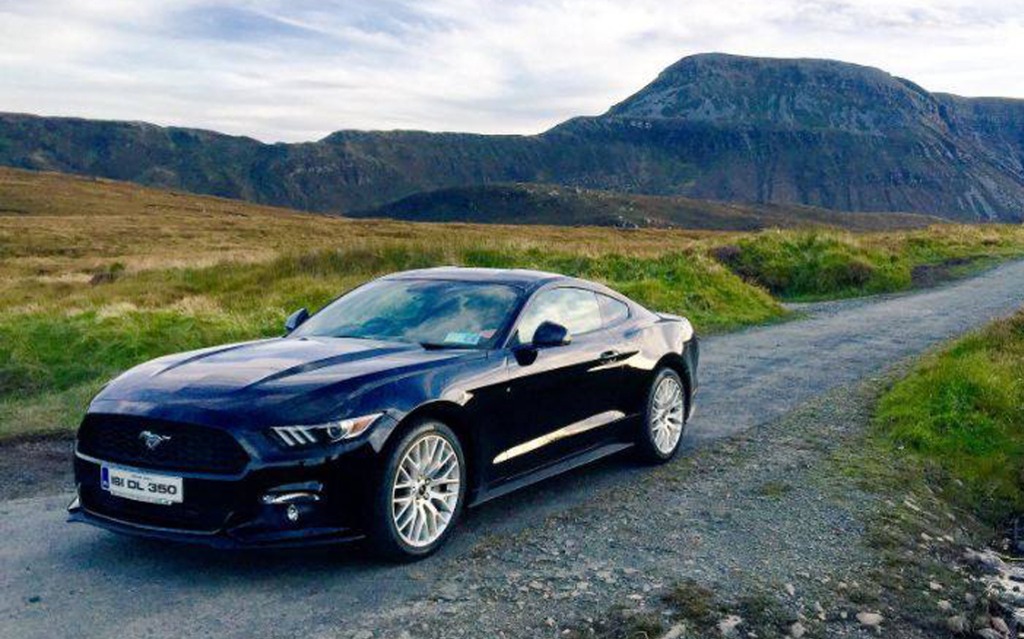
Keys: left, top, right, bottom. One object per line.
{"left": 0, "top": 0, "right": 1024, "bottom": 141}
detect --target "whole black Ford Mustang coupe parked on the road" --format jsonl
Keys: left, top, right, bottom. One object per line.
{"left": 70, "top": 268, "right": 697, "bottom": 558}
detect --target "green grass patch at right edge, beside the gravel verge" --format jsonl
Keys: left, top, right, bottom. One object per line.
{"left": 877, "top": 311, "right": 1024, "bottom": 524}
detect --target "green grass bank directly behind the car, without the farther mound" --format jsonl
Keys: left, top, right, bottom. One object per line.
{"left": 0, "top": 248, "right": 784, "bottom": 438}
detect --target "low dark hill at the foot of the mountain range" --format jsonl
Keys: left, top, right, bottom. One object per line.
{"left": 348, "top": 183, "right": 942, "bottom": 230}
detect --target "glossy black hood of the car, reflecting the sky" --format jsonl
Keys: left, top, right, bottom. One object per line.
{"left": 97, "top": 338, "right": 484, "bottom": 404}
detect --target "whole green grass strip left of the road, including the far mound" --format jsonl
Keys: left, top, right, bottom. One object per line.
{"left": 0, "top": 226, "right": 1016, "bottom": 438}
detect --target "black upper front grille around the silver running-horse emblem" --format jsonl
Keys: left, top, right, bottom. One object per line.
{"left": 78, "top": 415, "right": 249, "bottom": 474}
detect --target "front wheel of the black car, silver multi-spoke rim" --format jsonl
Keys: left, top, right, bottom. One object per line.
{"left": 368, "top": 419, "right": 466, "bottom": 561}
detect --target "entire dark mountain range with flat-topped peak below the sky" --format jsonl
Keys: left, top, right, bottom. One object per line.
{"left": 0, "top": 54, "right": 1024, "bottom": 222}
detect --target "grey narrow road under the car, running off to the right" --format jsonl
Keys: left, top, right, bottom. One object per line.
{"left": 0, "top": 261, "right": 1024, "bottom": 639}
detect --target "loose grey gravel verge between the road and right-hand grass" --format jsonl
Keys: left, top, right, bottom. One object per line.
{"left": 339, "top": 382, "right": 919, "bottom": 638}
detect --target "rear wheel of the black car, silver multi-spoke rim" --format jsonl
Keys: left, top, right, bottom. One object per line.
{"left": 637, "top": 367, "right": 686, "bottom": 464}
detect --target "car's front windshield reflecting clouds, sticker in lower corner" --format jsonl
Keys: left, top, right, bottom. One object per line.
{"left": 292, "top": 280, "right": 520, "bottom": 348}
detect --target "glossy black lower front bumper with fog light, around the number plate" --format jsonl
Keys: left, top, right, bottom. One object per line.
{"left": 68, "top": 453, "right": 365, "bottom": 548}
